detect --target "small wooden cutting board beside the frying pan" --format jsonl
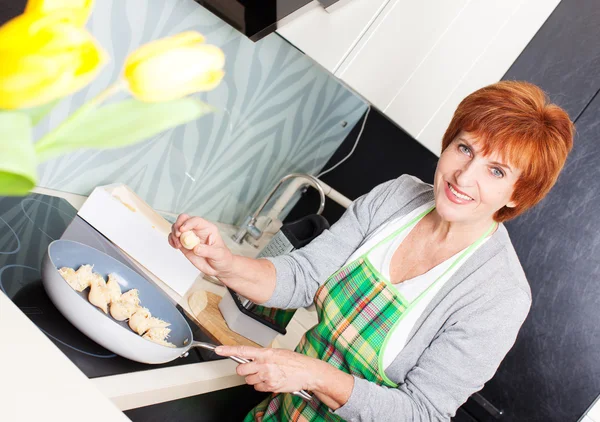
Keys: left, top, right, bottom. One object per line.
{"left": 188, "top": 290, "right": 262, "bottom": 347}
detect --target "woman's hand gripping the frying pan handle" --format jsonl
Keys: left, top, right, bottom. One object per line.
{"left": 215, "top": 346, "right": 329, "bottom": 393}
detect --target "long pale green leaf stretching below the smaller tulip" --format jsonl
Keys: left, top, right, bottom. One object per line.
{"left": 35, "top": 97, "right": 215, "bottom": 161}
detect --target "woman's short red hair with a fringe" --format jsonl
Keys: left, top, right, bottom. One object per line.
{"left": 442, "top": 81, "right": 575, "bottom": 223}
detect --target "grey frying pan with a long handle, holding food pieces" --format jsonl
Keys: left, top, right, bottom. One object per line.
{"left": 42, "top": 239, "right": 312, "bottom": 400}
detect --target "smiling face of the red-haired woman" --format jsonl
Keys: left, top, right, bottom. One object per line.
{"left": 433, "top": 131, "right": 521, "bottom": 222}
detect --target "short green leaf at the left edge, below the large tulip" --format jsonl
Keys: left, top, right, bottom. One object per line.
{"left": 0, "top": 111, "right": 36, "bottom": 196}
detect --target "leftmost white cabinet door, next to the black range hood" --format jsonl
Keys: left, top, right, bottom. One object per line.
{"left": 277, "top": 0, "right": 390, "bottom": 73}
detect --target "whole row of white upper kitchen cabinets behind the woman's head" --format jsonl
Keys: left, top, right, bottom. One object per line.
{"left": 279, "top": 0, "right": 560, "bottom": 155}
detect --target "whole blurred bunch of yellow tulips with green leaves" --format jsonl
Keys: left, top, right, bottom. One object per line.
{"left": 0, "top": 5, "right": 225, "bottom": 195}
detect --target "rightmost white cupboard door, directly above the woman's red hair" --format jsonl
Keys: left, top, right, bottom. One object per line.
{"left": 383, "top": 0, "right": 556, "bottom": 154}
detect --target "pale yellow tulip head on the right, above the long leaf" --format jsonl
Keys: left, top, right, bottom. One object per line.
{"left": 124, "top": 31, "right": 225, "bottom": 102}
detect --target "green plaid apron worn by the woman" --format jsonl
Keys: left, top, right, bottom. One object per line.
{"left": 244, "top": 207, "right": 495, "bottom": 422}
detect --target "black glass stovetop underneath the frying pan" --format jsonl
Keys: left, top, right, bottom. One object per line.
{"left": 0, "top": 193, "right": 224, "bottom": 378}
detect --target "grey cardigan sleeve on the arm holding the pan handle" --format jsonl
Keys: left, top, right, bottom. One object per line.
{"left": 334, "top": 288, "right": 531, "bottom": 422}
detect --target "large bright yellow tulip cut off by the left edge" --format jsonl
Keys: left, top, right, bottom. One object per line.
{"left": 0, "top": 11, "right": 107, "bottom": 109}
